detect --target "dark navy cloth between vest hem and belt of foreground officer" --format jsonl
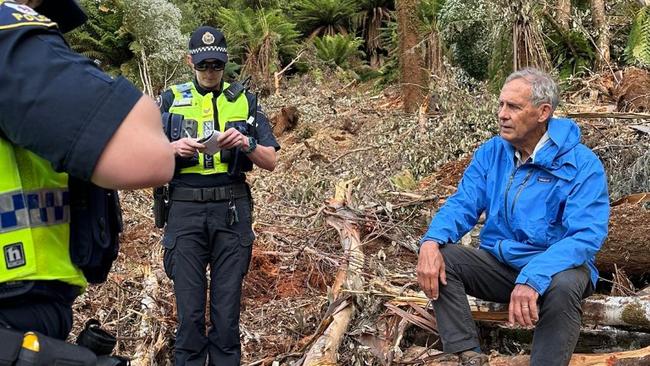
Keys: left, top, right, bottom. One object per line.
{"left": 0, "top": 297, "right": 72, "bottom": 340}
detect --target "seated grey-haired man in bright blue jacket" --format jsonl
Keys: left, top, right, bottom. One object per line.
{"left": 417, "top": 69, "right": 609, "bottom": 366}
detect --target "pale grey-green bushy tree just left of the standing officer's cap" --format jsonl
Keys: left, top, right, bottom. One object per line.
{"left": 124, "top": 0, "right": 187, "bottom": 96}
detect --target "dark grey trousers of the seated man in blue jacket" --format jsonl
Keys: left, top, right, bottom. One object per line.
{"left": 433, "top": 245, "right": 593, "bottom": 366}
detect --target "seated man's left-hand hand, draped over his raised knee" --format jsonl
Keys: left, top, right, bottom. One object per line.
{"left": 417, "top": 241, "right": 447, "bottom": 300}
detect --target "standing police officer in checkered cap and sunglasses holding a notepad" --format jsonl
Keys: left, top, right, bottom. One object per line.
{"left": 161, "top": 27, "right": 280, "bottom": 366}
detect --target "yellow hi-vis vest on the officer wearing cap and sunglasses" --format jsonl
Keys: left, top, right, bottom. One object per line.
{"left": 169, "top": 82, "right": 248, "bottom": 175}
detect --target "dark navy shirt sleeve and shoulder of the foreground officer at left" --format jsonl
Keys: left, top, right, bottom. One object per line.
{"left": 0, "top": 0, "right": 142, "bottom": 180}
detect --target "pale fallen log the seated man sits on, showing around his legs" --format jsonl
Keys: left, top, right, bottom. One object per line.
{"left": 373, "top": 281, "right": 650, "bottom": 330}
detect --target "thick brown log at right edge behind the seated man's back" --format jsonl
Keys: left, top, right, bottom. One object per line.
{"left": 596, "top": 204, "right": 650, "bottom": 275}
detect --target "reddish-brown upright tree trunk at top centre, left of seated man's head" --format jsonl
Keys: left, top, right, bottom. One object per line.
{"left": 396, "top": 0, "right": 427, "bottom": 113}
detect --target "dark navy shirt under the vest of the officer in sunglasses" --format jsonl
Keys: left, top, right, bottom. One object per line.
{"left": 160, "top": 80, "right": 280, "bottom": 188}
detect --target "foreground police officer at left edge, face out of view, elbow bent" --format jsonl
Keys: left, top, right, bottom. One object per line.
{"left": 0, "top": 0, "right": 174, "bottom": 344}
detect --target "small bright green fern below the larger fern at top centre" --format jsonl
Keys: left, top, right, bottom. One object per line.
{"left": 314, "top": 34, "right": 364, "bottom": 69}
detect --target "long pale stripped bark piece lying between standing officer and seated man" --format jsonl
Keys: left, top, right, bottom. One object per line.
{"left": 302, "top": 182, "right": 364, "bottom": 366}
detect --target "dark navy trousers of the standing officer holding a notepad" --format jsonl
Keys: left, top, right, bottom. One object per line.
{"left": 163, "top": 198, "right": 254, "bottom": 366}
